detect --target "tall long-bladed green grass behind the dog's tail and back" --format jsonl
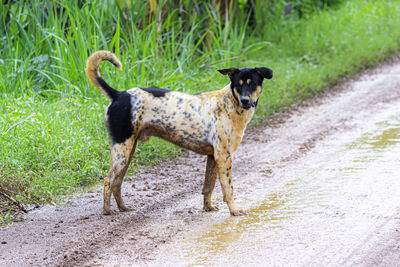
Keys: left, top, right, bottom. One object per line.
{"left": 0, "top": 0, "right": 256, "bottom": 97}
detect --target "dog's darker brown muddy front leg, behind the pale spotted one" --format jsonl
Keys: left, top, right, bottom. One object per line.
{"left": 202, "top": 156, "right": 218, "bottom": 211}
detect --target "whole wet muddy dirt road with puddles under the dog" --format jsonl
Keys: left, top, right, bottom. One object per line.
{"left": 0, "top": 60, "right": 400, "bottom": 266}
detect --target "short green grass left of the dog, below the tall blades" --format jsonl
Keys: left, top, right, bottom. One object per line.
{"left": 0, "top": 97, "right": 179, "bottom": 206}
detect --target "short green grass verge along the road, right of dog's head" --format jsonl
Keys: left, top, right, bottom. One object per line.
{"left": 252, "top": 1, "right": 400, "bottom": 121}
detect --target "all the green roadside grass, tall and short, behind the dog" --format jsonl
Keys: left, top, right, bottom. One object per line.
{"left": 0, "top": 0, "right": 400, "bottom": 220}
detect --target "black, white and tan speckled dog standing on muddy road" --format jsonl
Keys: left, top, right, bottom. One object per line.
{"left": 86, "top": 51, "right": 273, "bottom": 216}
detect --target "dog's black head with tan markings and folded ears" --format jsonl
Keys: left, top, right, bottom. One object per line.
{"left": 218, "top": 67, "right": 273, "bottom": 109}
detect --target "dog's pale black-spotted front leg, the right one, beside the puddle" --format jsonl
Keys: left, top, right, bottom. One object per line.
{"left": 217, "top": 152, "right": 246, "bottom": 216}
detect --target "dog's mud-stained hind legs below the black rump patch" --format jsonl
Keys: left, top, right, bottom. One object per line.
{"left": 103, "top": 136, "right": 137, "bottom": 215}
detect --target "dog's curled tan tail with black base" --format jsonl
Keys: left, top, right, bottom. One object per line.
{"left": 86, "top": 51, "right": 122, "bottom": 100}
